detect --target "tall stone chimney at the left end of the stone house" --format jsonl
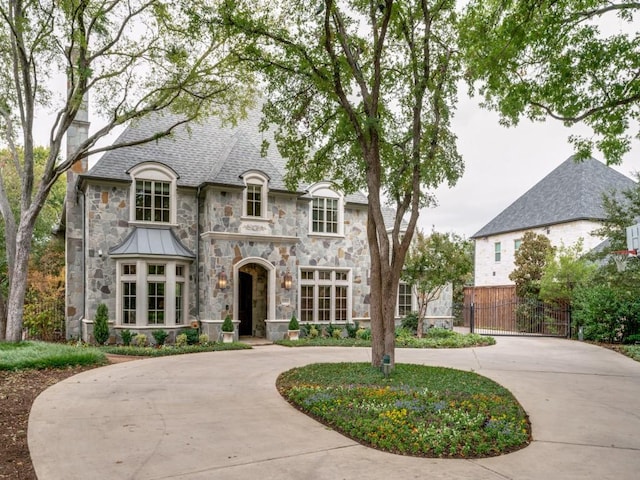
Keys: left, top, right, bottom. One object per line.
{"left": 65, "top": 86, "right": 89, "bottom": 338}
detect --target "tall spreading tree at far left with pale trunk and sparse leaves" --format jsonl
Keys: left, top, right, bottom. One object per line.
{"left": 0, "top": 0, "right": 252, "bottom": 342}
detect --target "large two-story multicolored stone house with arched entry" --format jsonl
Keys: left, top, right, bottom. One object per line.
{"left": 65, "top": 108, "right": 451, "bottom": 340}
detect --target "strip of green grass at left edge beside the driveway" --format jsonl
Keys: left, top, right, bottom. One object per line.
{"left": 0, "top": 342, "right": 107, "bottom": 370}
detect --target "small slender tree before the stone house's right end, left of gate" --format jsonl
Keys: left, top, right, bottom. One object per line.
{"left": 402, "top": 231, "right": 473, "bottom": 338}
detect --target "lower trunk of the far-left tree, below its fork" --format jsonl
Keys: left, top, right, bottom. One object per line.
{"left": 6, "top": 221, "right": 34, "bottom": 342}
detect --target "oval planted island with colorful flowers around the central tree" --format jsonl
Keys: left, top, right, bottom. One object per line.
{"left": 277, "top": 363, "right": 531, "bottom": 458}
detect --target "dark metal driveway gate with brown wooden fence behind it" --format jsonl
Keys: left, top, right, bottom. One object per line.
{"left": 463, "top": 285, "right": 571, "bottom": 337}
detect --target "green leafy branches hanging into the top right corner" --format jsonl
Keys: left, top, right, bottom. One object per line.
{"left": 460, "top": 0, "right": 640, "bottom": 164}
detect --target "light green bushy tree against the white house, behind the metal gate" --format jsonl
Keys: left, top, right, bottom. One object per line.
{"left": 540, "top": 239, "right": 597, "bottom": 304}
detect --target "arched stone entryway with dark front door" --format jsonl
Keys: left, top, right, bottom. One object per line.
{"left": 234, "top": 258, "right": 275, "bottom": 338}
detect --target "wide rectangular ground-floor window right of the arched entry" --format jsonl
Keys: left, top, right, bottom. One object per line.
{"left": 299, "top": 267, "right": 351, "bottom": 323}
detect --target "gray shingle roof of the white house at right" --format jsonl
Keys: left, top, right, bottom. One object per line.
{"left": 471, "top": 157, "right": 635, "bottom": 238}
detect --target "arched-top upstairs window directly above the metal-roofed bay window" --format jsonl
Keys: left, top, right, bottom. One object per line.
{"left": 128, "top": 162, "right": 178, "bottom": 224}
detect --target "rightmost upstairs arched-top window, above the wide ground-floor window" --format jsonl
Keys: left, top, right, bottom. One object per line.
{"left": 309, "top": 182, "right": 344, "bottom": 235}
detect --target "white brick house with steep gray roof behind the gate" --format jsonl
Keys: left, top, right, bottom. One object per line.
{"left": 471, "top": 157, "right": 635, "bottom": 286}
